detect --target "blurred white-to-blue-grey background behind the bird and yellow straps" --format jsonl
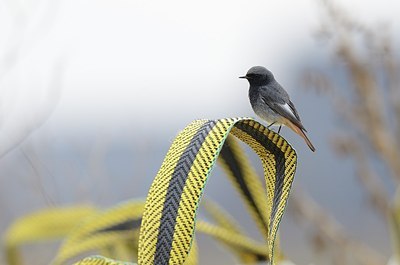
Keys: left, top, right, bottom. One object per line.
{"left": 0, "top": 0, "right": 400, "bottom": 265}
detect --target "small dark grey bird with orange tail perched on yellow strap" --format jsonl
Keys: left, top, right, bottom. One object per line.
{"left": 239, "top": 66, "right": 315, "bottom": 152}
